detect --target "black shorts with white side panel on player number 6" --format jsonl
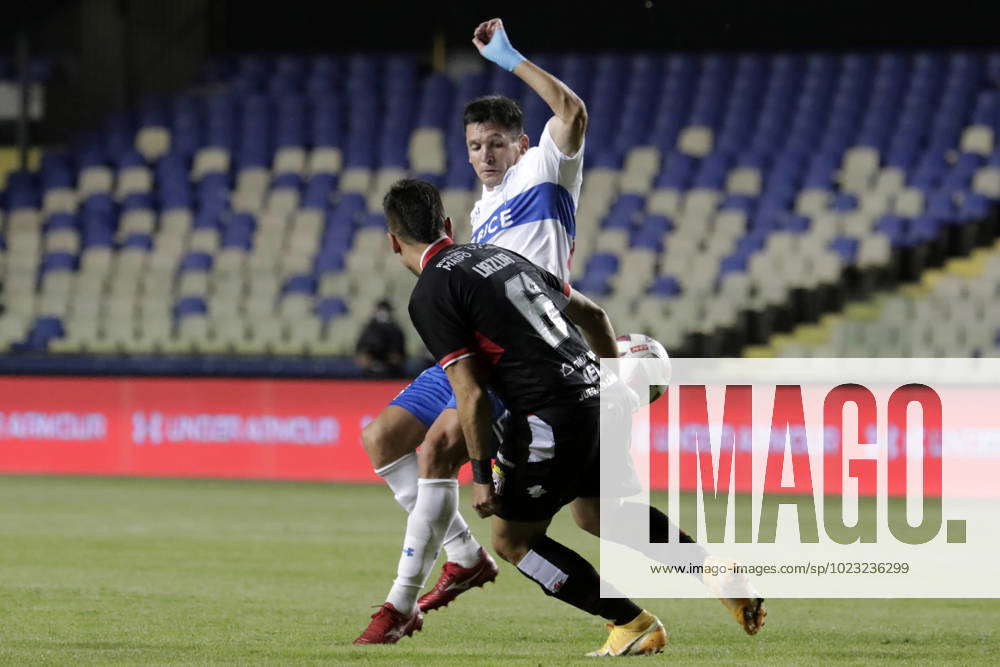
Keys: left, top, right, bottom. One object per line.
{"left": 493, "top": 405, "right": 601, "bottom": 521}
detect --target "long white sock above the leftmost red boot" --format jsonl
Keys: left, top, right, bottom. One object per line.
{"left": 386, "top": 479, "right": 458, "bottom": 615}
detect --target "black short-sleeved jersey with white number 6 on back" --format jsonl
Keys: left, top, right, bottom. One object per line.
{"left": 410, "top": 238, "right": 600, "bottom": 414}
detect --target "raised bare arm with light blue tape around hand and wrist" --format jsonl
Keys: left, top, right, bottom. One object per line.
{"left": 472, "top": 19, "right": 587, "bottom": 155}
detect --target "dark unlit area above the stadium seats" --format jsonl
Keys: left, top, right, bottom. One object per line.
{"left": 7, "top": 0, "right": 1000, "bottom": 145}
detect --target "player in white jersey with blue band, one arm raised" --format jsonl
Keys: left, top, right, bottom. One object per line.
{"left": 355, "top": 19, "right": 587, "bottom": 644}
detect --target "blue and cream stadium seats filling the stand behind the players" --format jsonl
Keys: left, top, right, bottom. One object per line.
{"left": 0, "top": 52, "right": 1000, "bottom": 358}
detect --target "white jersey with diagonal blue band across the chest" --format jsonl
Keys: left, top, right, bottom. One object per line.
{"left": 470, "top": 120, "right": 584, "bottom": 281}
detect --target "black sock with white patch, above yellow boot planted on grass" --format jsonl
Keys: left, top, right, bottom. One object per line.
{"left": 517, "top": 535, "right": 642, "bottom": 625}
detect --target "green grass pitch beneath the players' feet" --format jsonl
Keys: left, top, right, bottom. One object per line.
{"left": 0, "top": 476, "right": 1000, "bottom": 665}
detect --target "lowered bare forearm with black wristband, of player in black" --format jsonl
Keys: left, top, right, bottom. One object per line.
{"left": 445, "top": 357, "right": 497, "bottom": 517}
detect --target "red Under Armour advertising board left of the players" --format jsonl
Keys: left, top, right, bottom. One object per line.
{"left": 0, "top": 377, "right": 404, "bottom": 482}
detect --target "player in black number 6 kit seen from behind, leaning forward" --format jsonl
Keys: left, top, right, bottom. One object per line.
{"left": 385, "top": 180, "right": 666, "bottom": 656}
